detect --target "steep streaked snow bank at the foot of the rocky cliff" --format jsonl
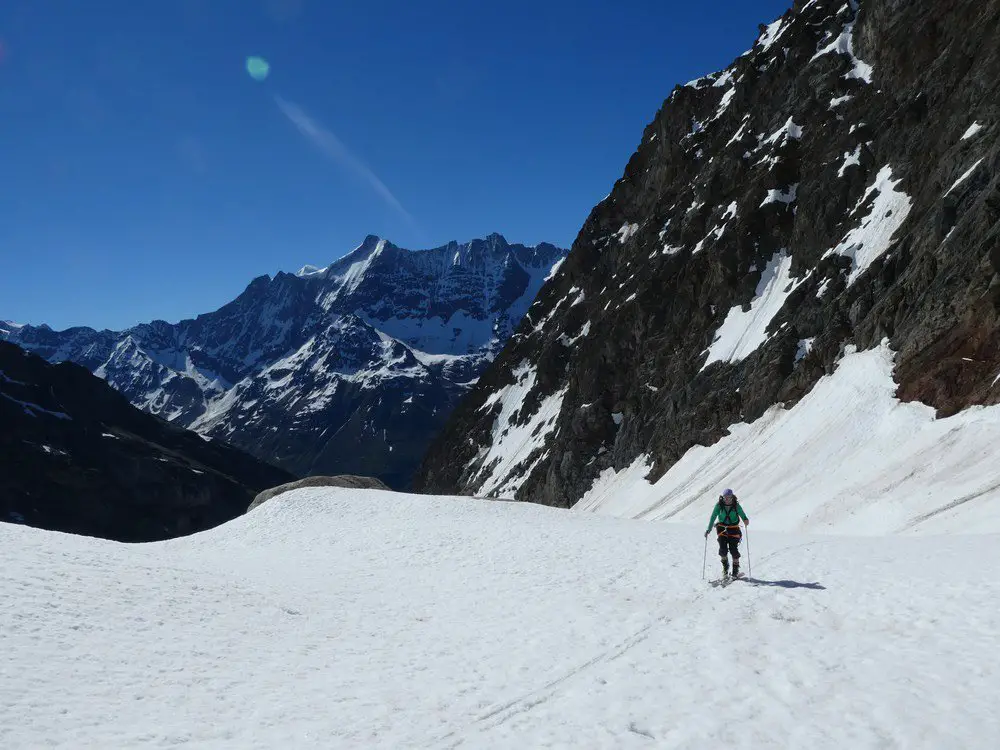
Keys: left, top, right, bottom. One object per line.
{"left": 576, "top": 344, "right": 1000, "bottom": 536}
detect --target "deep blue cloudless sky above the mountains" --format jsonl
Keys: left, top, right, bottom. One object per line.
{"left": 0, "top": 0, "right": 790, "bottom": 328}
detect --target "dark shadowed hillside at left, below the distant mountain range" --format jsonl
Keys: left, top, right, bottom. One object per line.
{"left": 0, "top": 341, "right": 291, "bottom": 542}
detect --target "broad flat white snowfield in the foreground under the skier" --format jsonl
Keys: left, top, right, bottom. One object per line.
{"left": 0, "top": 489, "right": 1000, "bottom": 750}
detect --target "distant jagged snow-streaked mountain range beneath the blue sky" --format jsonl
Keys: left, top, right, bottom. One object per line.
{"left": 0, "top": 234, "right": 566, "bottom": 487}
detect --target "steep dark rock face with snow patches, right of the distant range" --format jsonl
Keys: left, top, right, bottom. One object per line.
{"left": 417, "top": 0, "right": 1000, "bottom": 506}
